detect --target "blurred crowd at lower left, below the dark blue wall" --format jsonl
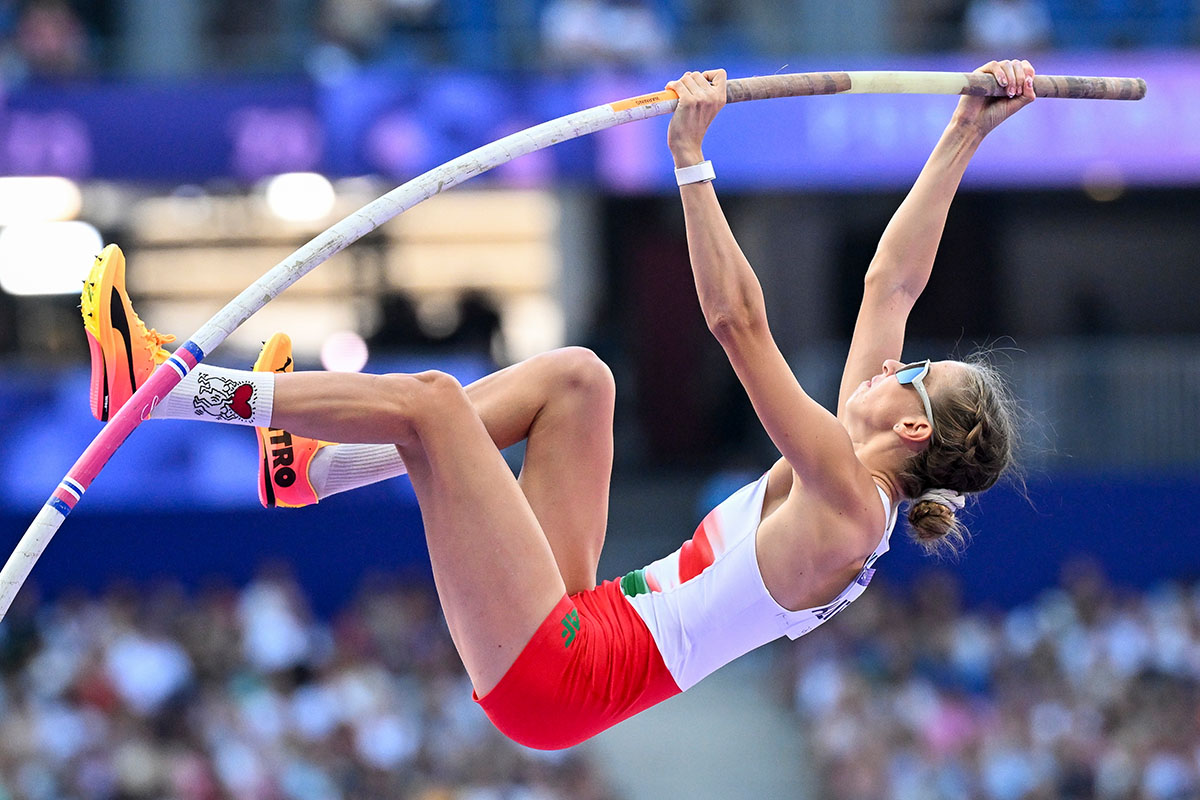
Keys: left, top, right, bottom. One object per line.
{"left": 0, "top": 573, "right": 612, "bottom": 800}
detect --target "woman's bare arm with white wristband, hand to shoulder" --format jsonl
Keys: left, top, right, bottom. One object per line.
{"left": 667, "top": 70, "right": 870, "bottom": 507}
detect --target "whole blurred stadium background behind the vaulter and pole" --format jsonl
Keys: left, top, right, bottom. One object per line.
{"left": 0, "top": 0, "right": 1200, "bottom": 800}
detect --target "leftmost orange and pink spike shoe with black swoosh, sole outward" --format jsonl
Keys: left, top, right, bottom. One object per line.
{"left": 79, "top": 245, "right": 175, "bottom": 422}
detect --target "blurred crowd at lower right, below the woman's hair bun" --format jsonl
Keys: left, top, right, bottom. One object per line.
{"left": 786, "top": 566, "right": 1200, "bottom": 800}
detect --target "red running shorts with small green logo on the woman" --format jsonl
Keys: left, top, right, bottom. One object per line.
{"left": 473, "top": 581, "right": 679, "bottom": 750}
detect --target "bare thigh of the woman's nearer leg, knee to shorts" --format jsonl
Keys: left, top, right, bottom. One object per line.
{"left": 397, "top": 377, "right": 565, "bottom": 696}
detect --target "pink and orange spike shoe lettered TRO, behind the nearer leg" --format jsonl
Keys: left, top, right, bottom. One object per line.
{"left": 254, "top": 333, "right": 330, "bottom": 509}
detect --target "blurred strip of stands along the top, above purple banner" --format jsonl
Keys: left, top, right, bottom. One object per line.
{"left": 0, "top": 0, "right": 1200, "bottom": 83}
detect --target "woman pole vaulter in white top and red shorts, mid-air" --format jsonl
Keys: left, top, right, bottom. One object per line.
{"left": 83, "top": 61, "right": 1033, "bottom": 748}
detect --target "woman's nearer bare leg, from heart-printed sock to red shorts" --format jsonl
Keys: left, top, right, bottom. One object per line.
{"left": 275, "top": 373, "right": 576, "bottom": 696}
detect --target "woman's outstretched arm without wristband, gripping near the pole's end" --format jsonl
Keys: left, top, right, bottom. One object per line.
{"left": 838, "top": 61, "right": 1034, "bottom": 415}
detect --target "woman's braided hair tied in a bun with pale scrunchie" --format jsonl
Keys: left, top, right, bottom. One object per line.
{"left": 896, "top": 350, "right": 1019, "bottom": 555}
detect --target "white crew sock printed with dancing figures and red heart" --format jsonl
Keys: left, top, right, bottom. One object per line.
{"left": 150, "top": 365, "right": 275, "bottom": 428}
